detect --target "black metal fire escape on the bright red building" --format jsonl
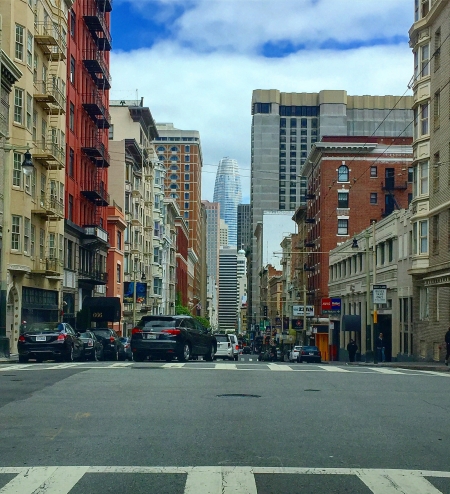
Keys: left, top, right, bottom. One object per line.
{"left": 79, "top": 0, "right": 112, "bottom": 285}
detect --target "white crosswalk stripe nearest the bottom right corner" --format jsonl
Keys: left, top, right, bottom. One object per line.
{"left": 357, "top": 470, "right": 441, "bottom": 494}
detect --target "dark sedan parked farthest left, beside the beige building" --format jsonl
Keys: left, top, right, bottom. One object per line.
{"left": 17, "top": 322, "right": 83, "bottom": 363}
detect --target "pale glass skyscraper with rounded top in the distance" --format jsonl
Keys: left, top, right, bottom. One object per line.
{"left": 213, "top": 157, "right": 242, "bottom": 246}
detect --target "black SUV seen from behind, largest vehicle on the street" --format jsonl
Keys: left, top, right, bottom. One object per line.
{"left": 131, "top": 315, "right": 217, "bottom": 362}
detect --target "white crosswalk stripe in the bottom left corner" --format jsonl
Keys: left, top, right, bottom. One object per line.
{"left": 0, "top": 467, "right": 89, "bottom": 494}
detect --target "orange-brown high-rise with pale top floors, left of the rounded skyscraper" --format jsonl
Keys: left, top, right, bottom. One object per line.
{"left": 156, "top": 123, "right": 203, "bottom": 310}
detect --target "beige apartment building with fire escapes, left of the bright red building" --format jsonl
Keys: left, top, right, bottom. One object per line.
{"left": 0, "top": 0, "right": 73, "bottom": 351}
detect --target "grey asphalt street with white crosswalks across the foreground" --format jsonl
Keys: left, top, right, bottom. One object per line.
{"left": 0, "top": 355, "right": 450, "bottom": 494}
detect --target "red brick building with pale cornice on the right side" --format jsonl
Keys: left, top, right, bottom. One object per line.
{"left": 300, "top": 136, "right": 412, "bottom": 350}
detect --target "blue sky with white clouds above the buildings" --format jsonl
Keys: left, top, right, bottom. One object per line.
{"left": 111, "top": 0, "right": 413, "bottom": 201}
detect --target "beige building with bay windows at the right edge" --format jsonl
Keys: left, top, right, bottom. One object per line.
{"left": 409, "top": 0, "right": 450, "bottom": 360}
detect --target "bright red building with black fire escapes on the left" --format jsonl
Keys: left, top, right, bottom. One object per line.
{"left": 63, "top": 0, "right": 112, "bottom": 323}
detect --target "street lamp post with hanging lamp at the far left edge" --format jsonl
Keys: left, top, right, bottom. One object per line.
{"left": 0, "top": 144, "right": 34, "bottom": 357}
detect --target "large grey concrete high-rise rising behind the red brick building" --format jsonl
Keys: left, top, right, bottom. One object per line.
{"left": 249, "top": 89, "right": 412, "bottom": 319}
